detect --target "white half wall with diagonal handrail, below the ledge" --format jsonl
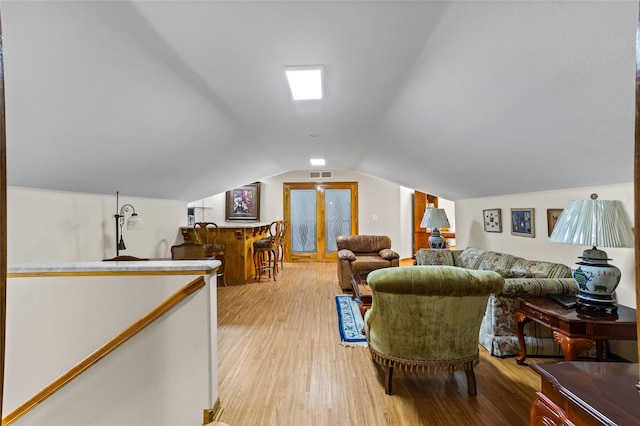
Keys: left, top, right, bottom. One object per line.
{"left": 3, "top": 275, "right": 218, "bottom": 426}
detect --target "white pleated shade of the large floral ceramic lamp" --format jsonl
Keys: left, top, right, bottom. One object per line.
{"left": 550, "top": 200, "right": 634, "bottom": 247}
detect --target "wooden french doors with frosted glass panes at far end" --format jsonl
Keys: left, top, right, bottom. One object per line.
{"left": 283, "top": 182, "right": 358, "bottom": 262}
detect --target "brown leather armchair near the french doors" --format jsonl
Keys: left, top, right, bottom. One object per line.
{"left": 336, "top": 235, "right": 400, "bottom": 290}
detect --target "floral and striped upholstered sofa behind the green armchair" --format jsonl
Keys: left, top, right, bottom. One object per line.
{"left": 416, "top": 248, "right": 578, "bottom": 357}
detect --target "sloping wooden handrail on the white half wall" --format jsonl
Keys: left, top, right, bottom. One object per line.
{"left": 2, "top": 276, "right": 205, "bottom": 426}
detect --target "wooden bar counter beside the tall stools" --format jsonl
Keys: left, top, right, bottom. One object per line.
{"left": 180, "top": 223, "right": 269, "bottom": 284}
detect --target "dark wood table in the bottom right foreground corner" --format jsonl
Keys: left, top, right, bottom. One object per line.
{"left": 529, "top": 362, "right": 640, "bottom": 426}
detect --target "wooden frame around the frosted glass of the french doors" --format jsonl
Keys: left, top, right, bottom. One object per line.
{"left": 282, "top": 182, "right": 358, "bottom": 262}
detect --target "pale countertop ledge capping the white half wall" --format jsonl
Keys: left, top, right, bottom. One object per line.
{"left": 7, "top": 260, "right": 222, "bottom": 275}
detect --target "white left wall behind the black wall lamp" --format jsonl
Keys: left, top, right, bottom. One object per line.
{"left": 7, "top": 187, "right": 187, "bottom": 265}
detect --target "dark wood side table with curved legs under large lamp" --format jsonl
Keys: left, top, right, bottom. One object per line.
{"left": 514, "top": 297, "right": 638, "bottom": 364}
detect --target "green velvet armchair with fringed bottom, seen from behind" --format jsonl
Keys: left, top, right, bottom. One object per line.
{"left": 364, "top": 266, "right": 504, "bottom": 395}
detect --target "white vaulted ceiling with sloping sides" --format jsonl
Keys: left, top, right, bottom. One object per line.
{"left": 0, "top": 0, "right": 638, "bottom": 201}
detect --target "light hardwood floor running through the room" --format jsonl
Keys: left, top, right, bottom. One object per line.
{"left": 218, "top": 263, "right": 561, "bottom": 426}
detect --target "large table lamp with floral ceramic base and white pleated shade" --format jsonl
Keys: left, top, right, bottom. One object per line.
{"left": 550, "top": 194, "right": 634, "bottom": 312}
